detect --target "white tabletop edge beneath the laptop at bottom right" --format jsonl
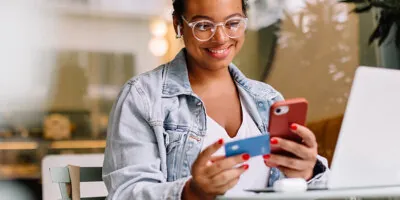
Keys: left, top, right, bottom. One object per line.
{"left": 217, "top": 186, "right": 400, "bottom": 200}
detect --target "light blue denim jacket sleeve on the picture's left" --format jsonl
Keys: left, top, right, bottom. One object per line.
{"left": 103, "top": 83, "right": 188, "bottom": 200}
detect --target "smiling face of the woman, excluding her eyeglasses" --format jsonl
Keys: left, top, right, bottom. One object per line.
{"left": 177, "top": 0, "right": 245, "bottom": 70}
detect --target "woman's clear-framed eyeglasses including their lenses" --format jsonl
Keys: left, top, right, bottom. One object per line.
{"left": 182, "top": 16, "right": 248, "bottom": 42}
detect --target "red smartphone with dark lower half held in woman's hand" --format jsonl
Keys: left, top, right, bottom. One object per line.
{"left": 268, "top": 98, "right": 308, "bottom": 157}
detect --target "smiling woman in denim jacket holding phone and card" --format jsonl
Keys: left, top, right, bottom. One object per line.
{"left": 103, "top": 0, "right": 327, "bottom": 199}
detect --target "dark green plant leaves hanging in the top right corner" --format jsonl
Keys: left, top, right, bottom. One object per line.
{"left": 339, "top": 0, "right": 400, "bottom": 69}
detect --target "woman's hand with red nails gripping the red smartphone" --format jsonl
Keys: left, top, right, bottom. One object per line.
{"left": 264, "top": 124, "right": 318, "bottom": 181}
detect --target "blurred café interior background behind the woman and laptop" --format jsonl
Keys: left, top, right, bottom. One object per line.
{"left": 0, "top": 0, "right": 400, "bottom": 199}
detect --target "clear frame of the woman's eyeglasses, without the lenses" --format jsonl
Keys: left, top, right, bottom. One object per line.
{"left": 181, "top": 16, "right": 248, "bottom": 42}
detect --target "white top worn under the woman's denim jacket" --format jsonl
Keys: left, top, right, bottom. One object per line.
{"left": 202, "top": 99, "right": 269, "bottom": 195}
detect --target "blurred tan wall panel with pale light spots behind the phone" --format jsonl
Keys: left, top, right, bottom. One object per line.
{"left": 265, "top": 0, "right": 359, "bottom": 122}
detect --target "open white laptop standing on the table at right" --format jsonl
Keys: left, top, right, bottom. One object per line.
{"left": 247, "top": 66, "right": 400, "bottom": 192}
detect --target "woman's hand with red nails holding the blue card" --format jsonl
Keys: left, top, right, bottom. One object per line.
{"left": 183, "top": 139, "right": 250, "bottom": 199}
